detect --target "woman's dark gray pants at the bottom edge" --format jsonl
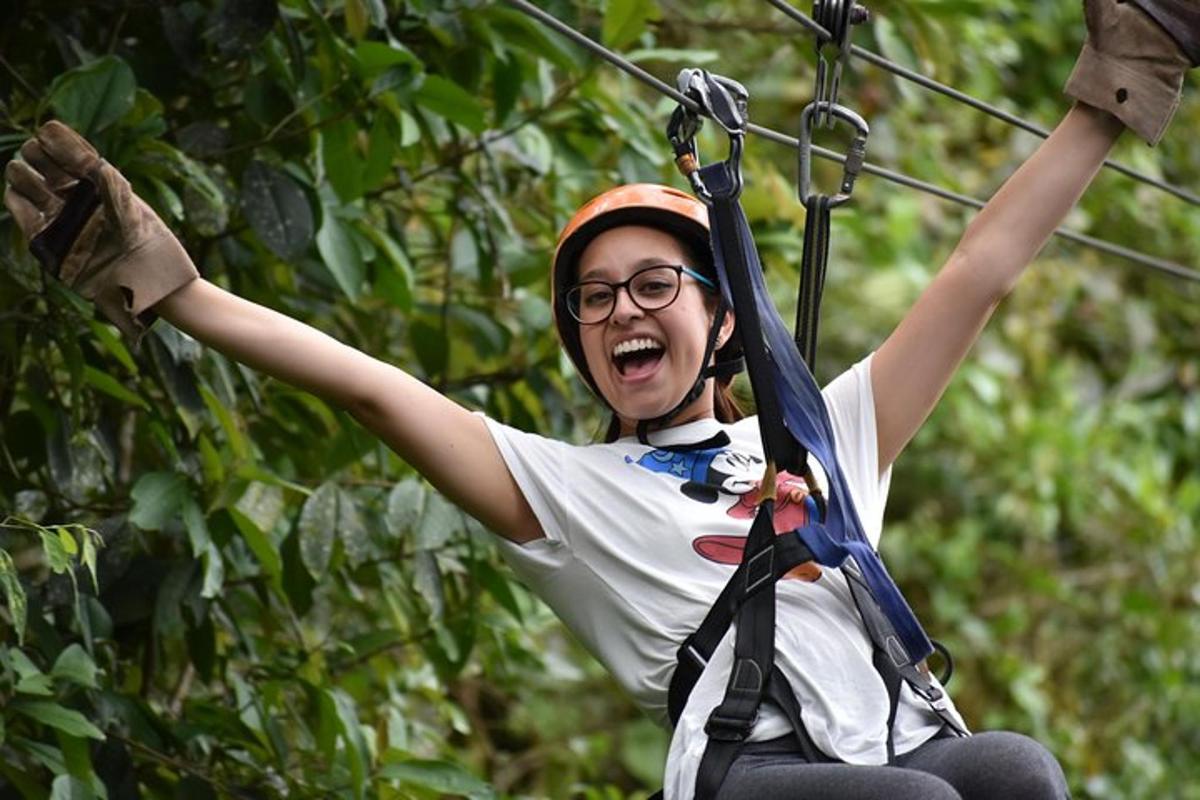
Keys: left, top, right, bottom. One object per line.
{"left": 718, "top": 730, "right": 1070, "bottom": 800}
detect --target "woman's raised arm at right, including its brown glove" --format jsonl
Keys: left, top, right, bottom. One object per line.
{"left": 871, "top": 0, "right": 1200, "bottom": 470}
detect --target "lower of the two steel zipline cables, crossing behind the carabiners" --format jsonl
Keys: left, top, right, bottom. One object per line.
{"left": 504, "top": 0, "right": 1200, "bottom": 283}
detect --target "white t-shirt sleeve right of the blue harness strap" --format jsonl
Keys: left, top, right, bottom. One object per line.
{"left": 821, "top": 354, "right": 892, "bottom": 547}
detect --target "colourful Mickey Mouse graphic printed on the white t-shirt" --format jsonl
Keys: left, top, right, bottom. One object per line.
{"left": 625, "top": 449, "right": 821, "bottom": 581}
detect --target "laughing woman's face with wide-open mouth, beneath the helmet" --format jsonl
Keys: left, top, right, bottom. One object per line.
{"left": 577, "top": 225, "right": 733, "bottom": 434}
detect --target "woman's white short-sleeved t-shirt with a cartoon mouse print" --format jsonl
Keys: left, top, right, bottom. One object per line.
{"left": 477, "top": 356, "right": 964, "bottom": 800}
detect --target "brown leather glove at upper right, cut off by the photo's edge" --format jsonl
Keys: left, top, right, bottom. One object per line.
{"left": 1064, "top": 0, "right": 1200, "bottom": 145}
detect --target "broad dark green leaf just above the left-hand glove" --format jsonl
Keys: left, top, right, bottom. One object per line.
{"left": 49, "top": 55, "right": 138, "bottom": 137}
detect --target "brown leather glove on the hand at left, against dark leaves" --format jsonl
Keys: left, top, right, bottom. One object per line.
{"left": 4, "top": 121, "right": 199, "bottom": 341}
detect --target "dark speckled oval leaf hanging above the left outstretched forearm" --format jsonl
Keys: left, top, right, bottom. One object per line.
{"left": 241, "top": 161, "right": 314, "bottom": 259}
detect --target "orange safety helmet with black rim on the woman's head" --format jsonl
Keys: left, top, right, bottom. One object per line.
{"left": 550, "top": 184, "right": 716, "bottom": 402}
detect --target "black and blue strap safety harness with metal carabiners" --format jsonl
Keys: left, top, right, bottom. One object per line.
{"left": 652, "top": 10, "right": 968, "bottom": 800}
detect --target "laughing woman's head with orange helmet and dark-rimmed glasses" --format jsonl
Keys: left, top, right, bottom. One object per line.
{"left": 551, "top": 184, "right": 743, "bottom": 441}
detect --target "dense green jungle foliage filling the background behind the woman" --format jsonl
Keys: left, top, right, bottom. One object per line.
{"left": 0, "top": 0, "right": 1200, "bottom": 800}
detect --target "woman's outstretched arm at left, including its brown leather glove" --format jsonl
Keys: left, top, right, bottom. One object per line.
{"left": 4, "top": 121, "right": 544, "bottom": 542}
